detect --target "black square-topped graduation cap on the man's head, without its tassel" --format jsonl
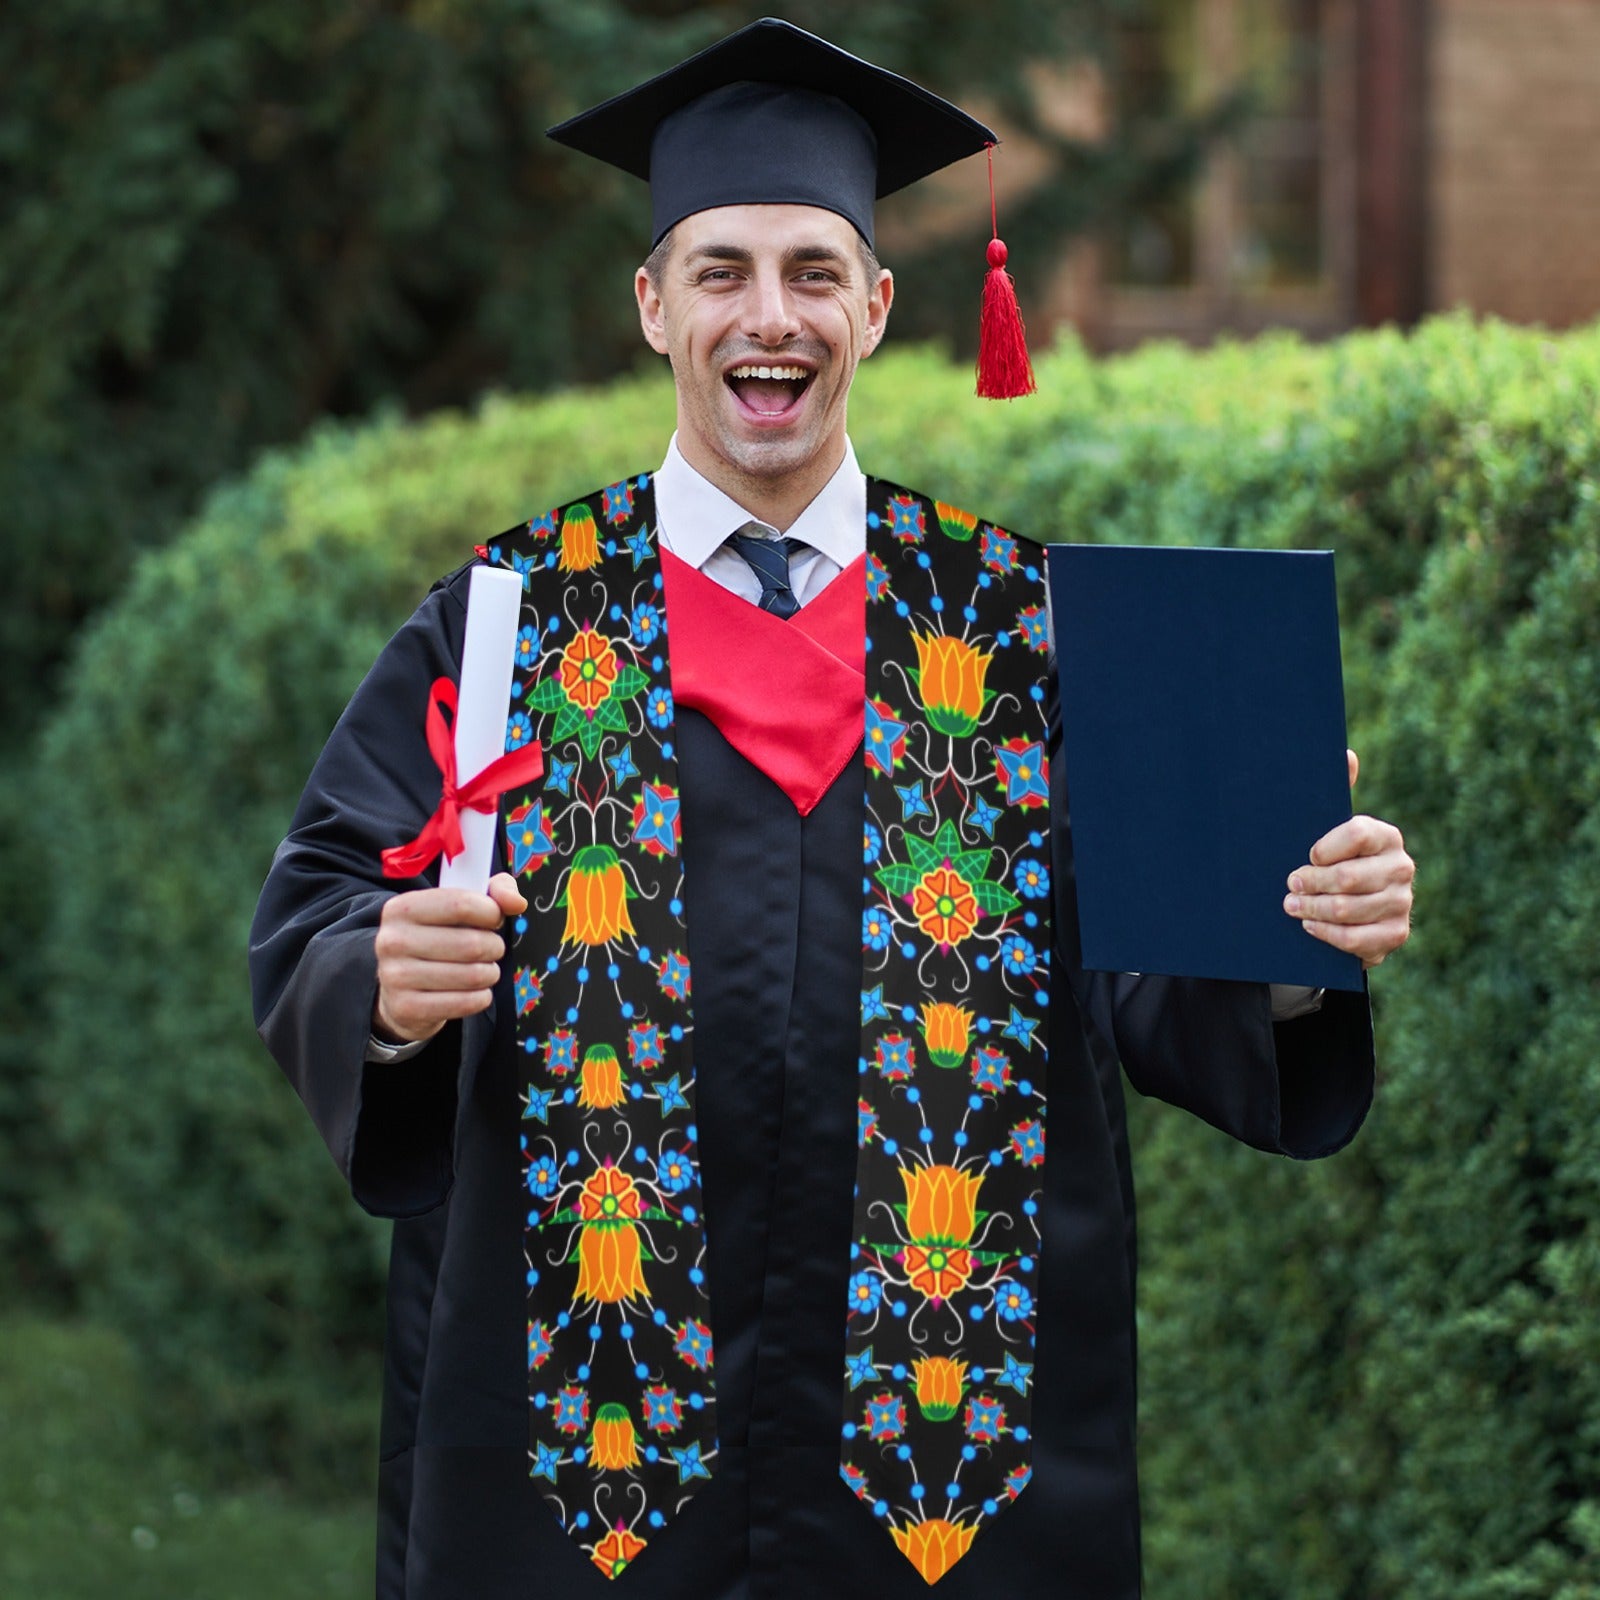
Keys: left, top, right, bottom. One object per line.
{"left": 549, "top": 18, "right": 998, "bottom": 245}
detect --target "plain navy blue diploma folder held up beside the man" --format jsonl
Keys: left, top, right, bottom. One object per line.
{"left": 1050, "top": 544, "right": 1362, "bottom": 989}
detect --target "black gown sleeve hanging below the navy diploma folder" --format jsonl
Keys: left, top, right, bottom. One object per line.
{"left": 1050, "top": 672, "right": 1374, "bottom": 1160}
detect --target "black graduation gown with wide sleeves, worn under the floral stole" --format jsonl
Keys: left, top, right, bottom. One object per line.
{"left": 251, "top": 556, "right": 1373, "bottom": 1600}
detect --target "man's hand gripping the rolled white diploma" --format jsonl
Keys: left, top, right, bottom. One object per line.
{"left": 373, "top": 872, "right": 528, "bottom": 1043}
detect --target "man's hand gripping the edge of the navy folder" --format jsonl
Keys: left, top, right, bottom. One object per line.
{"left": 1283, "top": 750, "right": 1416, "bottom": 966}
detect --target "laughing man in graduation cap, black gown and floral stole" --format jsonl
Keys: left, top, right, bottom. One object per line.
{"left": 253, "top": 22, "right": 1411, "bottom": 1600}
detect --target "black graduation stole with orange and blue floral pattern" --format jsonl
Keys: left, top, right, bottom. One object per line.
{"left": 488, "top": 475, "right": 1050, "bottom": 1584}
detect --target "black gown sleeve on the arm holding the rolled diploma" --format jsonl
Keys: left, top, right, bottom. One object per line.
{"left": 250, "top": 568, "right": 491, "bottom": 1216}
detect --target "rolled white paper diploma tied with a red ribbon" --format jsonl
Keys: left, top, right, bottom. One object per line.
{"left": 438, "top": 566, "right": 522, "bottom": 894}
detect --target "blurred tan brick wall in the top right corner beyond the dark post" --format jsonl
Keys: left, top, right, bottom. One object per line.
{"left": 1429, "top": 0, "right": 1600, "bottom": 326}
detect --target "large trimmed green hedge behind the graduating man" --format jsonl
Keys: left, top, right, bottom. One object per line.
{"left": 28, "top": 318, "right": 1600, "bottom": 1600}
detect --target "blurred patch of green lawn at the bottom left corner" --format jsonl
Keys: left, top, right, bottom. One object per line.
{"left": 0, "top": 1315, "right": 373, "bottom": 1600}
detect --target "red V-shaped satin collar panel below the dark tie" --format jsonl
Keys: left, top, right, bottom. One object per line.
{"left": 661, "top": 550, "right": 867, "bottom": 816}
